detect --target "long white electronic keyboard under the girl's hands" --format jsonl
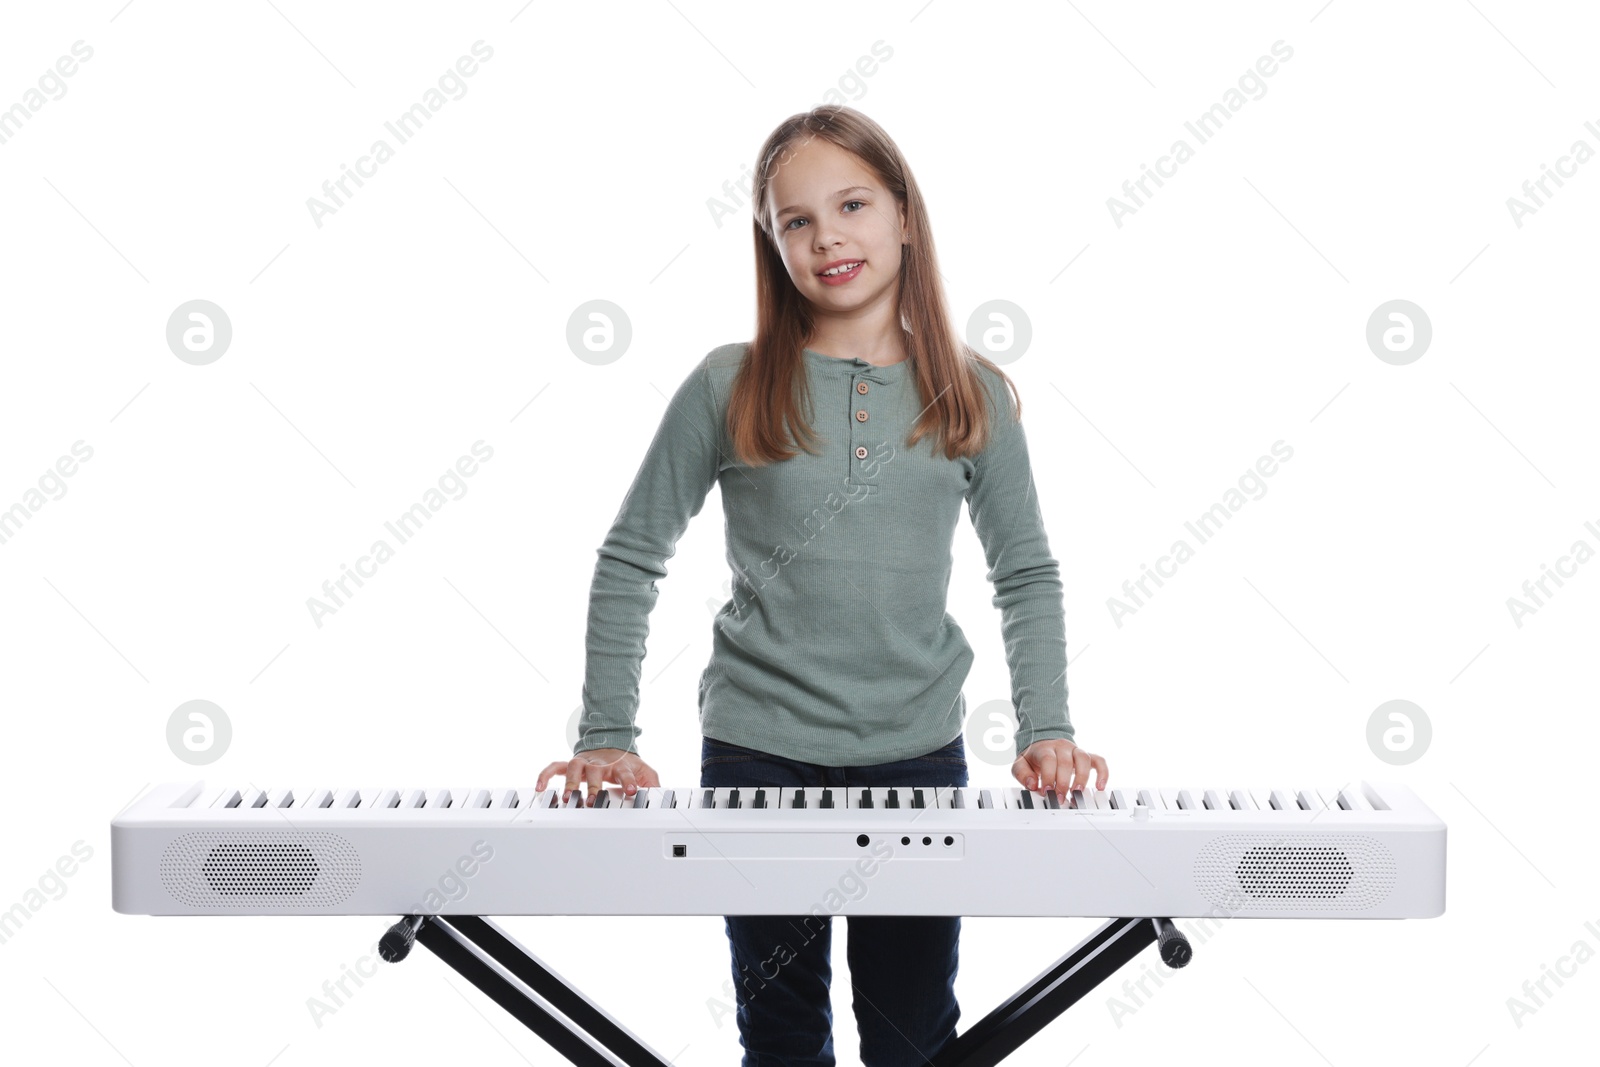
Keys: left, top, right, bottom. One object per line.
{"left": 112, "top": 779, "right": 1445, "bottom": 918}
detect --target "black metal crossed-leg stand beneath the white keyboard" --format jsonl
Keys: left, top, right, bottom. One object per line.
{"left": 378, "top": 915, "right": 1192, "bottom": 1067}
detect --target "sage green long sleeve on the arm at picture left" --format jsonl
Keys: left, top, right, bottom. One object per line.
{"left": 573, "top": 357, "right": 722, "bottom": 755}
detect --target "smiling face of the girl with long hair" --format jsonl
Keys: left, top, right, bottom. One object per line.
{"left": 768, "top": 138, "right": 906, "bottom": 312}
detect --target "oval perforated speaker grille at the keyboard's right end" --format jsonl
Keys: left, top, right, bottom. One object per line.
{"left": 1194, "top": 833, "right": 1395, "bottom": 913}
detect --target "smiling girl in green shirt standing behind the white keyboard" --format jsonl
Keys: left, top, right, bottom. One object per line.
{"left": 536, "top": 106, "right": 1109, "bottom": 1067}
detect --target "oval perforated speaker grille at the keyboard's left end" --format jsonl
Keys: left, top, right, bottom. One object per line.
{"left": 162, "top": 830, "right": 362, "bottom": 909}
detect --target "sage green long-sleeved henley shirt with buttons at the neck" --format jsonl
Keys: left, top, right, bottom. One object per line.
{"left": 574, "top": 344, "right": 1074, "bottom": 766}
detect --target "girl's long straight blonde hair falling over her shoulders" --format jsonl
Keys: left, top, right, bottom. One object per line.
{"left": 728, "top": 104, "right": 1022, "bottom": 466}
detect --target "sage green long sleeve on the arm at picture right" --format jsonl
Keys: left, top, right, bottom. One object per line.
{"left": 966, "top": 374, "right": 1074, "bottom": 755}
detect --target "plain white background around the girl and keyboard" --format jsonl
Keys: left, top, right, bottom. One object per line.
{"left": 0, "top": 0, "right": 1600, "bottom": 1067}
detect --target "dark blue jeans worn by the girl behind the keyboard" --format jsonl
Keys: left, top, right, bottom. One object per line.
{"left": 701, "top": 736, "right": 966, "bottom": 1067}
